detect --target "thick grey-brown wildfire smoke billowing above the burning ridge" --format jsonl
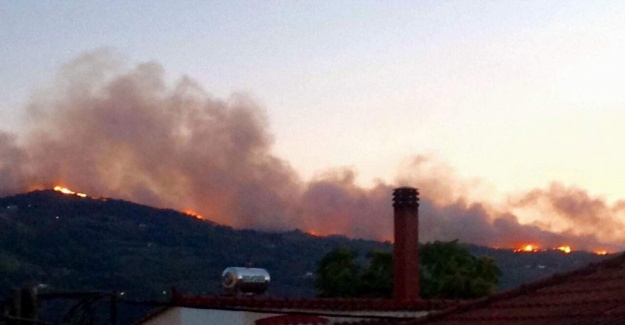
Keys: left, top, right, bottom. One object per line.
{"left": 0, "top": 51, "right": 625, "bottom": 249}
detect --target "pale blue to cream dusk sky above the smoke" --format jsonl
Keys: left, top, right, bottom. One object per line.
{"left": 0, "top": 0, "right": 625, "bottom": 249}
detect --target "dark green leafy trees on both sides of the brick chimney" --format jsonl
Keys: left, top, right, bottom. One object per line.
{"left": 315, "top": 241, "right": 501, "bottom": 299}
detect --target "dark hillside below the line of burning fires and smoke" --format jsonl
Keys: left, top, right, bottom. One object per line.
{"left": 0, "top": 190, "right": 602, "bottom": 298}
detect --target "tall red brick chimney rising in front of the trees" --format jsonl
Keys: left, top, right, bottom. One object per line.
{"left": 393, "top": 187, "right": 419, "bottom": 302}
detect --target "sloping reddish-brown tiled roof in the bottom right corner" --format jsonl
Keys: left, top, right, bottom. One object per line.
{"left": 402, "top": 254, "right": 625, "bottom": 325}
